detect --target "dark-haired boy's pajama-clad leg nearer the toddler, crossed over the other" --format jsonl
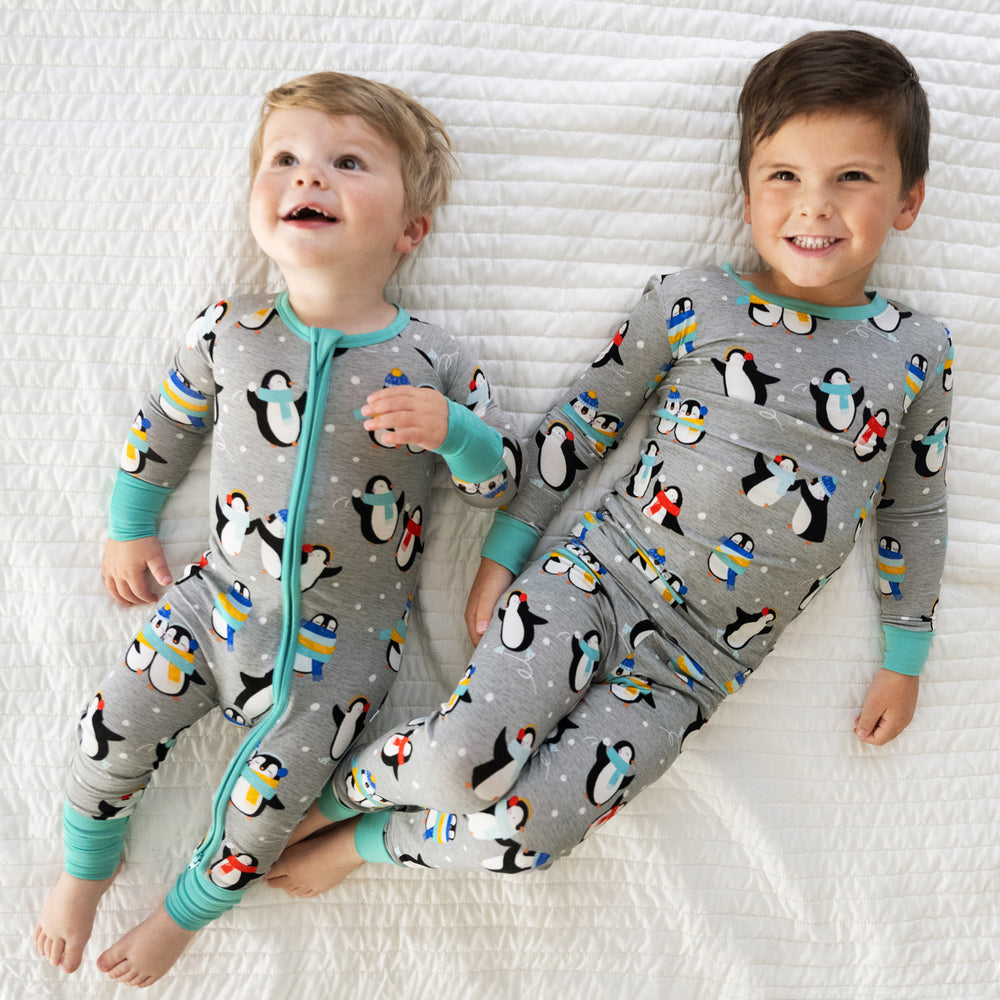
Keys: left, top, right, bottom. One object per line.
{"left": 320, "top": 563, "right": 619, "bottom": 820}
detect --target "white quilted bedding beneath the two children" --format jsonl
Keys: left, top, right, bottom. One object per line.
{"left": 0, "top": 0, "right": 1000, "bottom": 1000}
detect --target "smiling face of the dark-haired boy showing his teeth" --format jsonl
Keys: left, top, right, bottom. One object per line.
{"left": 743, "top": 111, "right": 924, "bottom": 306}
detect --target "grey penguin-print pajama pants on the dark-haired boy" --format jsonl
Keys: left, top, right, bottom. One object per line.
{"left": 320, "top": 550, "right": 722, "bottom": 872}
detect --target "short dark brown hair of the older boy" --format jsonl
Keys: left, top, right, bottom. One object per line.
{"left": 737, "top": 31, "right": 930, "bottom": 191}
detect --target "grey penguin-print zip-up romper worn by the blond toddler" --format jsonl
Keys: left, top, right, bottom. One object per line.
{"left": 69, "top": 296, "right": 520, "bottom": 924}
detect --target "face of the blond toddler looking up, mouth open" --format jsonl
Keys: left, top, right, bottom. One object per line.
{"left": 250, "top": 108, "right": 430, "bottom": 294}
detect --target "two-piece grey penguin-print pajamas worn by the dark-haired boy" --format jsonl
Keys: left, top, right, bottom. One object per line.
{"left": 324, "top": 269, "right": 951, "bottom": 872}
